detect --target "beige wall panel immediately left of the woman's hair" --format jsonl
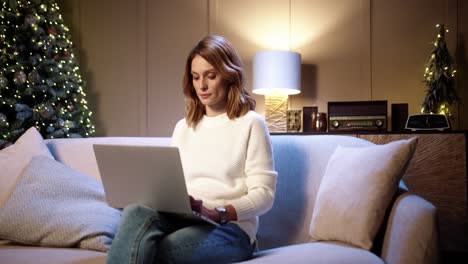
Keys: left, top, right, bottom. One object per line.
{"left": 146, "top": 0, "right": 208, "bottom": 136}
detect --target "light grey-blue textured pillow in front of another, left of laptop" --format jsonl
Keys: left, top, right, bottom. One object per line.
{"left": 0, "top": 156, "right": 121, "bottom": 251}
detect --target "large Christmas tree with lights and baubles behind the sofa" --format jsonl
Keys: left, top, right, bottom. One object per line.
{"left": 0, "top": 0, "right": 95, "bottom": 148}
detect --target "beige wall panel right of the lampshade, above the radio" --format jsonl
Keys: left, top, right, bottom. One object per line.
{"left": 291, "top": 0, "right": 372, "bottom": 112}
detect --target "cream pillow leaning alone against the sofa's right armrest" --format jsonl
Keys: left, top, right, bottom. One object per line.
{"left": 309, "top": 138, "right": 417, "bottom": 250}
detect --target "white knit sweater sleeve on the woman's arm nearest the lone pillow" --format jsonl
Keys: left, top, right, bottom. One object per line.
{"left": 231, "top": 116, "right": 278, "bottom": 221}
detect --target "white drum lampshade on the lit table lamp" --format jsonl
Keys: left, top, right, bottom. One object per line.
{"left": 252, "top": 50, "right": 301, "bottom": 95}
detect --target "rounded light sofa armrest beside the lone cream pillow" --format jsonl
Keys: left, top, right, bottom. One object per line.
{"left": 381, "top": 192, "right": 439, "bottom": 264}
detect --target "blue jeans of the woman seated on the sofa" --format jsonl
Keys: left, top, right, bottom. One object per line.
{"left": 107, "top": 205, "right": 254, "bottom": 264}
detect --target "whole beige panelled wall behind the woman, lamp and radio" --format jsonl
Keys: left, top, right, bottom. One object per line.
{"left": 60, "top": 0, "right": 468, "bottom": 136}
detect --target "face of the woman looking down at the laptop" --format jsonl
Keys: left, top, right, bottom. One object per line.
{"left": 192, "top": 55, "right": 227, "bottom": 116}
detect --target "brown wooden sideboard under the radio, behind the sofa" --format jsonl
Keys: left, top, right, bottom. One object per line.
{"left": 359, "top": 133, "right": 468, "bottom": 252}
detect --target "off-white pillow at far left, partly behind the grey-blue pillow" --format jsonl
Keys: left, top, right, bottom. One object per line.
{"left": 0, "top": 127, "right": 54, "bottom": 208}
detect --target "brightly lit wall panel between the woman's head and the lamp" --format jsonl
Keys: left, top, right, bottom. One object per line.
{"left": 209, "top": 0, "right": 290, "bottom": 114}
